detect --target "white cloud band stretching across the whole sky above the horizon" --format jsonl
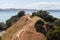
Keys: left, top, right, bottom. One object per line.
{"left": 0, "top": 2, "right": 60, "bottom": 10}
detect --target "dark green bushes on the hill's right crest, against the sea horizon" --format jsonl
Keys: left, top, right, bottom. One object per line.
{"left": 32, "top": 10, "right": 57, "bottom": 23}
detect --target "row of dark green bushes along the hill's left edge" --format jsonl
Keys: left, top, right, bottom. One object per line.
{"left": 6, "top": 11, "right": 25, "bottom": 27}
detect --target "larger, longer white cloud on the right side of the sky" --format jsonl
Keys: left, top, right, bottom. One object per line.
{"left": 26, "top": 2, "right": 60, "bottom": 10}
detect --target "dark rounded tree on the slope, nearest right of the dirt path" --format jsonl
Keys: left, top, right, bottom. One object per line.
{"left": 35, "top": 20, "right": 46, "bottom": 34}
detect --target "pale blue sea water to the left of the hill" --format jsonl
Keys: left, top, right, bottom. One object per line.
{"left": 0, "top": 11, "right": 18, "bottom": 22}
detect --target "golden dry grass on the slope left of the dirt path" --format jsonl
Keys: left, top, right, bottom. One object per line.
{"left": 2, "top": 17, "right": 29, "bottom": 40}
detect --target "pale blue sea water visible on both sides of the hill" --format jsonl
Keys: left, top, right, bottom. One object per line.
{"left": 0, "top": 11, "right": 60, "bottom": 22}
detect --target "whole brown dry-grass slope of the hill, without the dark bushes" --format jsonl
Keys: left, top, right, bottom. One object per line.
{"left": 2, "top": 15, "right": 47, "bottom": 40}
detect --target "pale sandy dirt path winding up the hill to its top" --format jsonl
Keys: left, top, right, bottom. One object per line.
{"left": 12, "top": 16, "right": 32, "bottom": 40}
